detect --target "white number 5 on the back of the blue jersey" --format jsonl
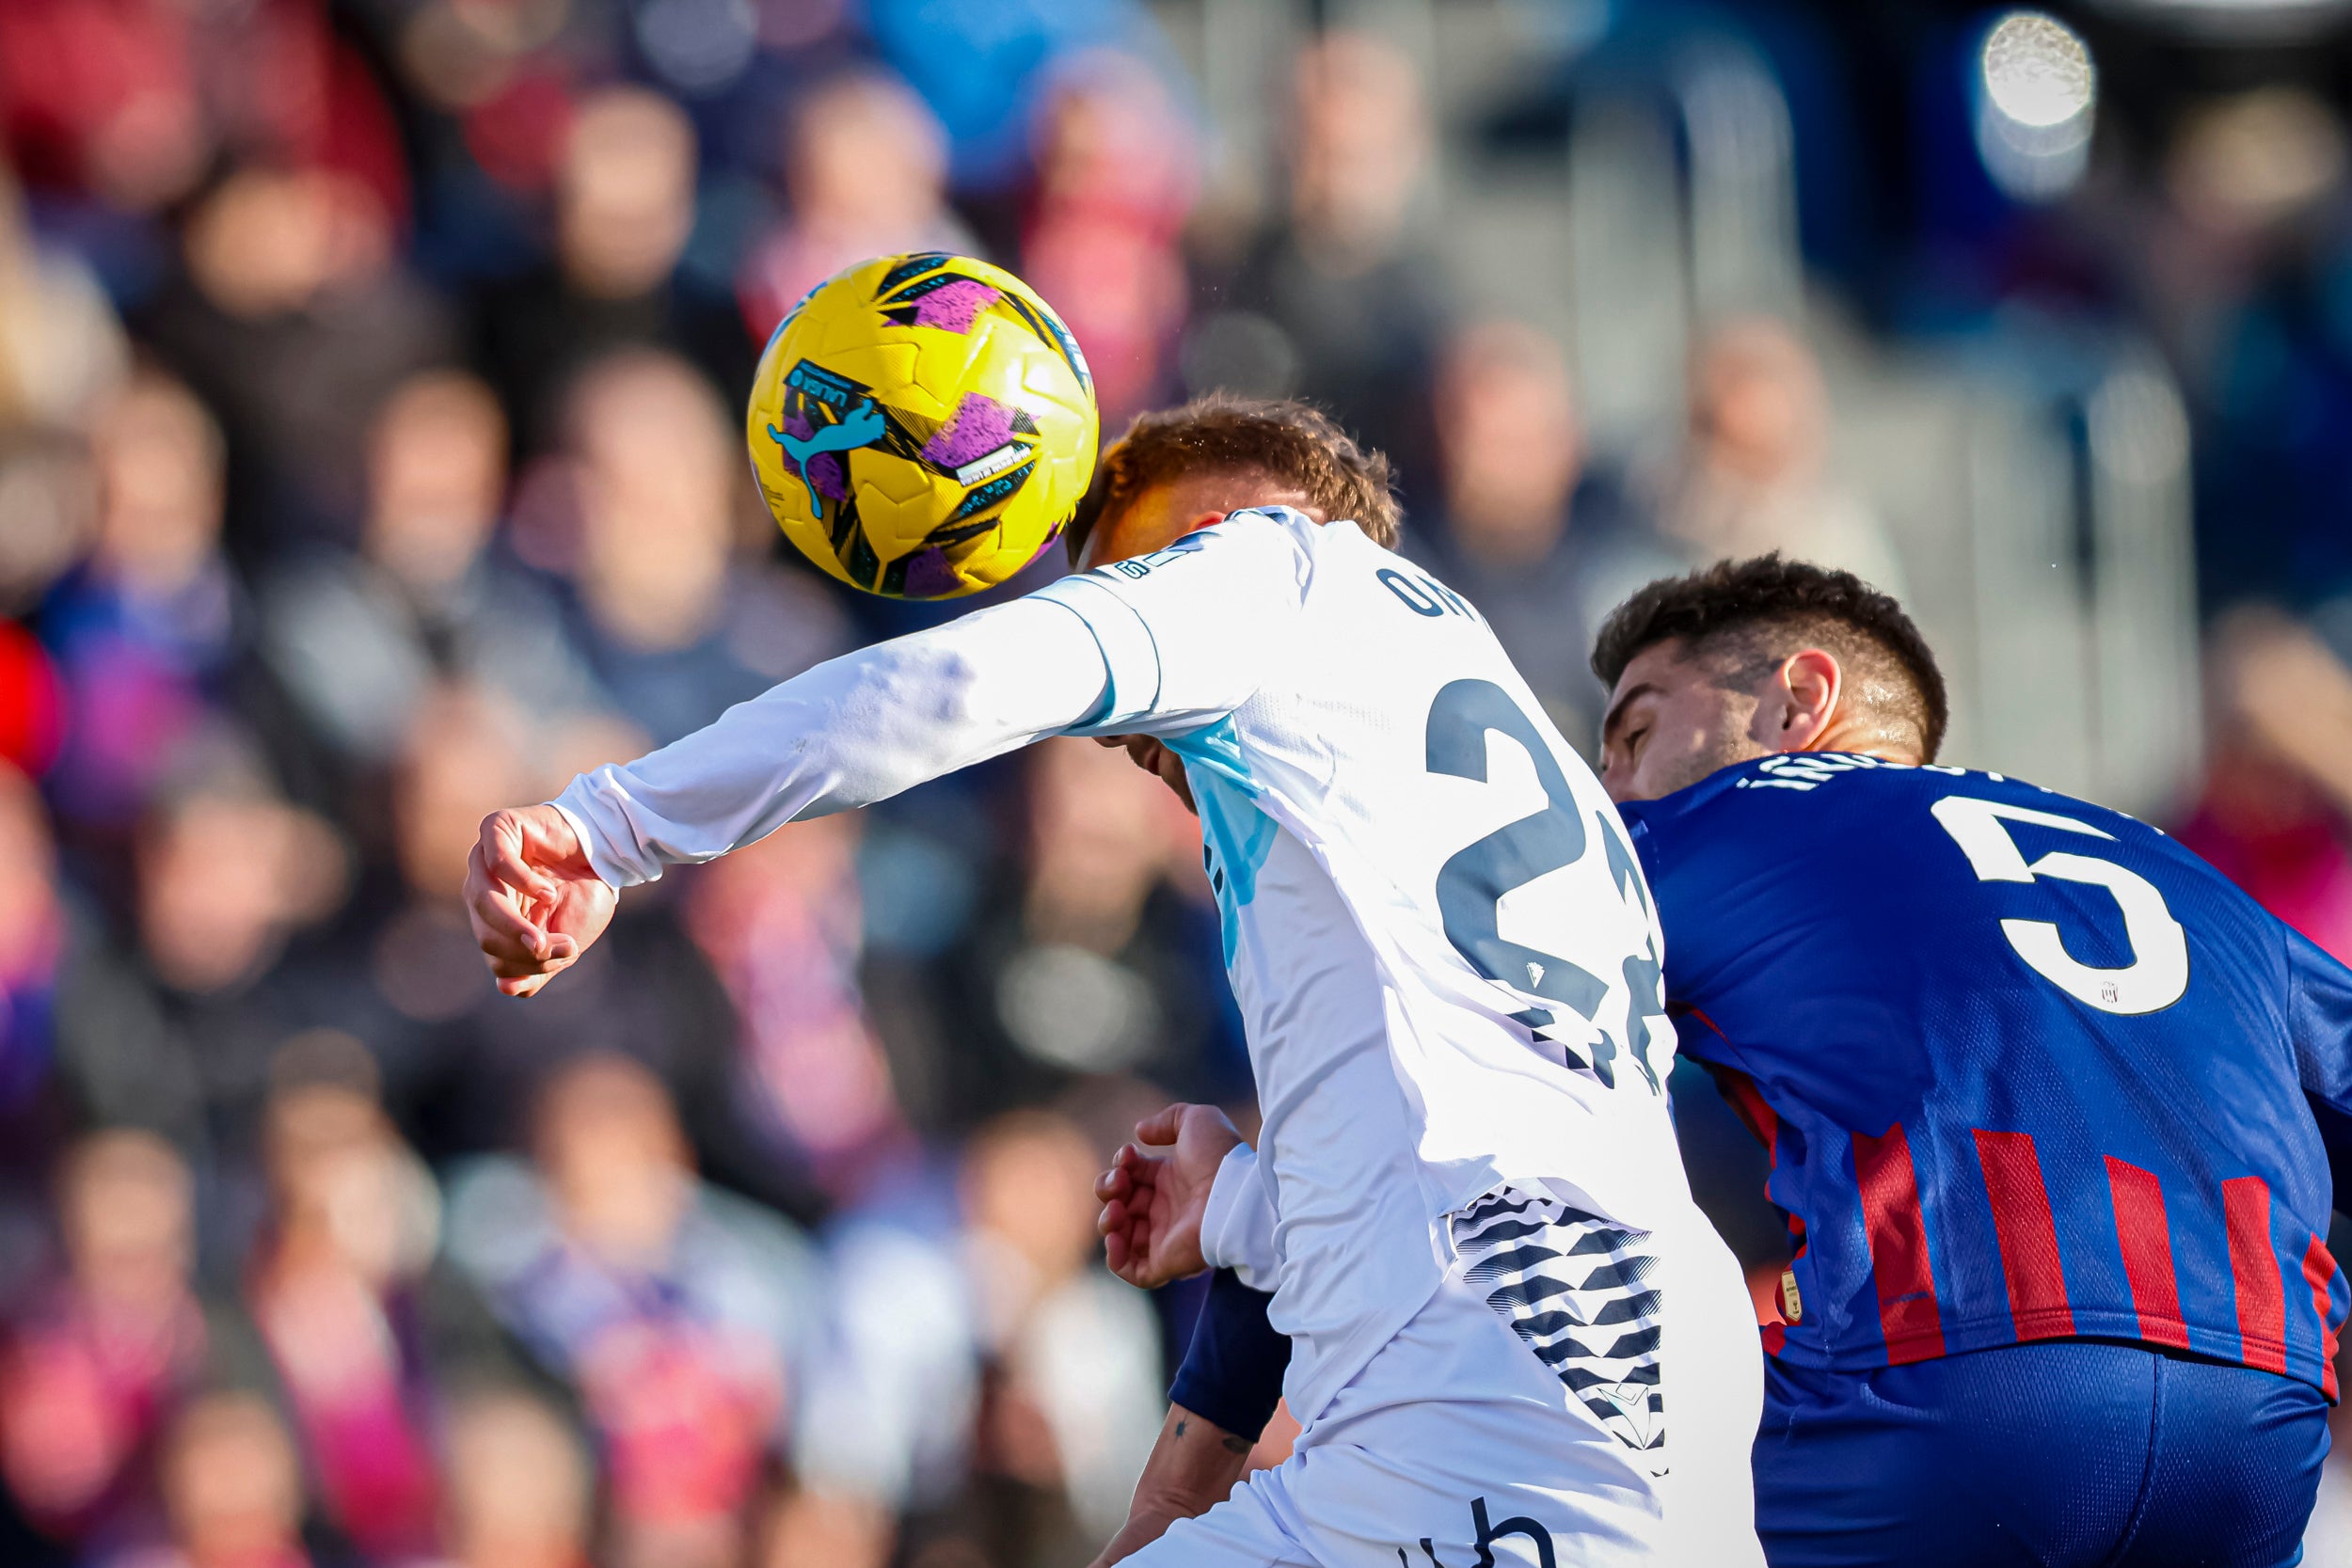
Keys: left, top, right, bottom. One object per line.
{"left": 1929, "top": 795, "right": 2190, "bottom": 1016}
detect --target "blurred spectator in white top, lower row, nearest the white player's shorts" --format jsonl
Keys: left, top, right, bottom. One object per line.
{"left": 964, "top": 1112, "right": 1167, "bottom": 1561}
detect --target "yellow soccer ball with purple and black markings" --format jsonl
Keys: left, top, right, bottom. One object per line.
{"left": 748, "top": 251, "right": 1099, "bottom": 599}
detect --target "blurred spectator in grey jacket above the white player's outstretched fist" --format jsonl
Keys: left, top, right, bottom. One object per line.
{"left": 262, "top": 372, "right": 596, "bottom": 764}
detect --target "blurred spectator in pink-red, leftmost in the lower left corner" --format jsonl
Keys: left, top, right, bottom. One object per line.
{"left": 0, "top": 1131, "right": 207, "bottom": 1559}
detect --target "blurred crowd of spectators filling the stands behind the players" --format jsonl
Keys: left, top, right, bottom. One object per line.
{"left": 0, "top": 0, "right": 2352, "bottom": 1568}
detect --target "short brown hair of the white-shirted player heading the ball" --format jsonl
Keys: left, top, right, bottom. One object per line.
{"left": 1063, "top": 392, "right": 1397, "bottom": 564}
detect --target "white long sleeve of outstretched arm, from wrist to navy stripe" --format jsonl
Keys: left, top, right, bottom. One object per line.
{"left": 555, "top": 594, "right": 1110, "bottom": 886}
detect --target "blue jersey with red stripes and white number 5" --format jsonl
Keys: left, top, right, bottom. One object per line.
{"left": 1623, "top": 754, "right": 2352, "bottom": 1399}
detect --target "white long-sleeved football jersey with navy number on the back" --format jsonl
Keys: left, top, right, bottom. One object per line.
{"left": 558, "top": 508, "right": 1689, "bottom": 1422}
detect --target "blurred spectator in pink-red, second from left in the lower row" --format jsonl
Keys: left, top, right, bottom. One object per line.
{"left": 245, "top": 1067, "right": 454, "bottom": 1561}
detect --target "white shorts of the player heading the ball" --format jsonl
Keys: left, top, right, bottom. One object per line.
{"left": 1127, "top": 1195, "right": 1764, "bottom": 1568}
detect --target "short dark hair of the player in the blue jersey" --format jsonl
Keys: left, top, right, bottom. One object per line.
{"left": 1593, "top": 550, "right": 1952, "bottom": 762}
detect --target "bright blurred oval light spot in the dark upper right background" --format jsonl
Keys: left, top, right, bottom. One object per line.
{"left": 1976, "top": 11, "right": 2098, "bottom": 202}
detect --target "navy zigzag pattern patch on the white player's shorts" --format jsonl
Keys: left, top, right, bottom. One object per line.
{"left": 1452, "top": 1187, "right": 1665, "bottom": 1477}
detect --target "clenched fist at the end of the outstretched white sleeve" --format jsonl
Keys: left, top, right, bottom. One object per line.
{"left": 466, "top": 806, "right": 619, "bottom": 997}
